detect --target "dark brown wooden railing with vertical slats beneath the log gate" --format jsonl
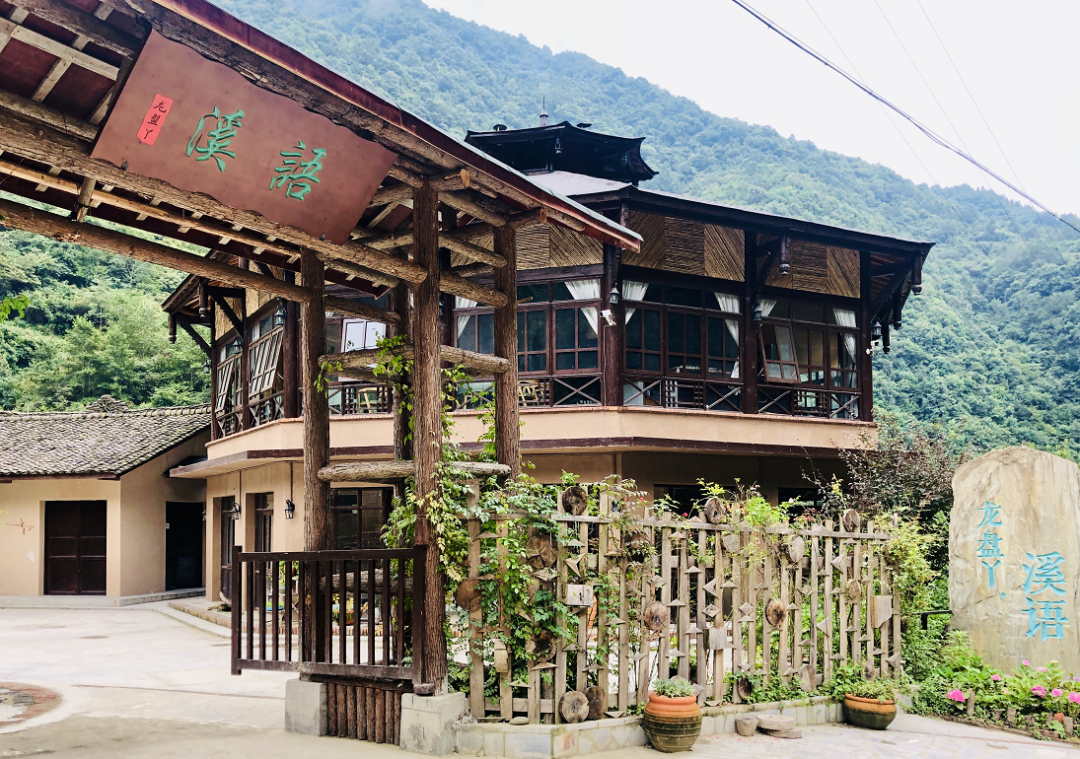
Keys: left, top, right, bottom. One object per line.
{"left": 232, "top": 546, "right": 424, "bottom": 681}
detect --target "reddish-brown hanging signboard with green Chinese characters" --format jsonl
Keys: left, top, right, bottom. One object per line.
{"left": 93, "top": 32, "right": 395, "bottom": 244}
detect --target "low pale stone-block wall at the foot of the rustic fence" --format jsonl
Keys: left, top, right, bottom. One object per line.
{"left": 457, "top": 696, "right": 842, "bottom": 759}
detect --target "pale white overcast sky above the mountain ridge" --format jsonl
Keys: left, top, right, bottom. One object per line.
{"left": 424, "top": 0, "right": 1080, "bottom": 220}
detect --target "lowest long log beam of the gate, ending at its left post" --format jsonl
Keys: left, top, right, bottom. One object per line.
{"left": 0, "top": 200, "right": 308, "bottom": 302}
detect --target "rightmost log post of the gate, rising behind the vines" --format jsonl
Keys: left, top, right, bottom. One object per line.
{"left": 495, "top": 225, "right": 522, "bottom": 479}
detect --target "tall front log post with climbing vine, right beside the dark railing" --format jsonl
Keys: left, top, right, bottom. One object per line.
{"left": 413, "top": 182, "right": 446, "bottom": 693}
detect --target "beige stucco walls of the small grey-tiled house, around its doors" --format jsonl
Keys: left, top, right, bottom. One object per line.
{"left": 0, "top": 433, "right": 208, "bottom": 596}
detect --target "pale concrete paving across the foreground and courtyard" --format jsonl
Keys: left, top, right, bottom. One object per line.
{"left": 0, "top": 604, "right": 1080, "bottom": 759}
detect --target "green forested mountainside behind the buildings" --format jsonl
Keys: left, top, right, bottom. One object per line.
{"left": 0, "top": 0, "right": 1080, "bottom": 446}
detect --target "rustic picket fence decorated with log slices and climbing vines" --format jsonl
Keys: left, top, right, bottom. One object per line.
{"left": 458, "top": 491, "right": 901, "bottom": 723}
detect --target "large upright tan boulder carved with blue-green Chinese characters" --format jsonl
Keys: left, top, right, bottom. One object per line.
{"left": 948, "top": 447, "right": 1080, "bottom": 675}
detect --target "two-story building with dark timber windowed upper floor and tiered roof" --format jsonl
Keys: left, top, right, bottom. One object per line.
{"left": 165, "top": 122, "right": 932, "bottom": 596}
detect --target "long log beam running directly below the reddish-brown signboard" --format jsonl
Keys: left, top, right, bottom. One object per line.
{"left": 0, "top": 112, "right": 427, "bottom": 289}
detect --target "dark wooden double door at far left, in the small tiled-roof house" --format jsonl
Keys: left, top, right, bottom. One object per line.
{"left": 45, "top": 501, "right": 108, "bottom": 595}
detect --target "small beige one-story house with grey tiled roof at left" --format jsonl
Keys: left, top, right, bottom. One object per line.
{"left": 0, "top": 395, "right": 210, "bottom": 604}
